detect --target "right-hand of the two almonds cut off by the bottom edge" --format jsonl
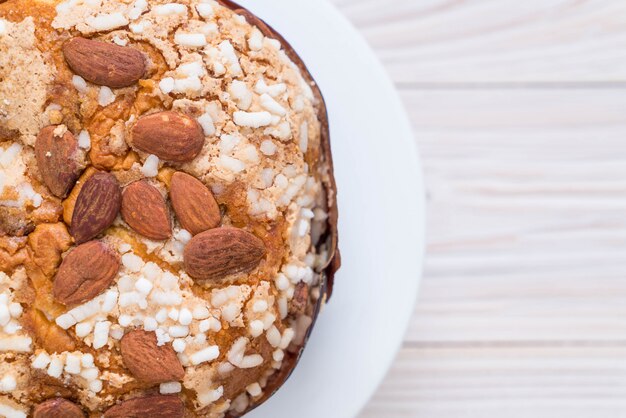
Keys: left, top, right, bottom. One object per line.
{"left": 104, "top": 395, "right": 185, "bottom": 418}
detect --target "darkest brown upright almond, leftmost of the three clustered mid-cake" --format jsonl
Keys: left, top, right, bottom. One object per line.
{"left": 70, "top": 172, "right": 122, "bottom": 244}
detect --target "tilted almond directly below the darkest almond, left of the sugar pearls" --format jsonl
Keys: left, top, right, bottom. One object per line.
{"left": 52, "top": 241, "right": 120, "bottom": 306}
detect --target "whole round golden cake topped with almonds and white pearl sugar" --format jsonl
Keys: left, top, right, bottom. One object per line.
{"left": 0, "top": 0, "right": 339, "bottom": 418}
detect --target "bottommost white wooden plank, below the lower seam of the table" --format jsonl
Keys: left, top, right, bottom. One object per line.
{"left": 361, "top": 346, "right": 626, "bottom": 418}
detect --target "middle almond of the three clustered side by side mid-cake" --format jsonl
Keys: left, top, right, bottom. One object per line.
{"left": 122, "top": 180, "right": 172, "bottom": 241}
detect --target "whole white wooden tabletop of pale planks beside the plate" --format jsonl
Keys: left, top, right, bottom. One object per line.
{"left": 322, "top": 0, "right": 626, "bottom": 418}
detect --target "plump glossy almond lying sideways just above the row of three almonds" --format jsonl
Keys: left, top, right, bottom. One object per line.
{"left": 131, "top": 111, "right": 204, "bottom": 163}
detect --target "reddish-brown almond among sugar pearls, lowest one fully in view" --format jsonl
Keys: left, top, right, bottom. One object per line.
{"left": 120, "top": 330, "right": 185, "bottom": 384}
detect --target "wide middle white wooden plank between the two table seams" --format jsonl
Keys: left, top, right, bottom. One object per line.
{"left": 403, "top": 89, "right": 626, "bottom": 343}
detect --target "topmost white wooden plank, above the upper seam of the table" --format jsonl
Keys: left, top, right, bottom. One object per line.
{"left": 334, "top": 0, "right": 626, "bottom": 84}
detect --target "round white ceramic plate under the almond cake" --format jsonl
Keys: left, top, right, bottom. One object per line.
{"left": 240, "top": 0, "right": 424, "bottom": 418}
